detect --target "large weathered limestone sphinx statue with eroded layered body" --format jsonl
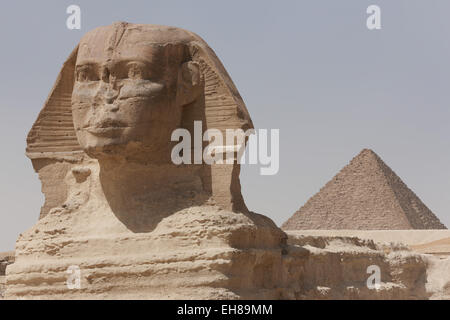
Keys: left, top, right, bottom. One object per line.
{"left": 6, "top": 22, "right": 286, "bottom": 299}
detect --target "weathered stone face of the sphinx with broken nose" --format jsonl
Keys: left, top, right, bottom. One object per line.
{"left": 72, "top": 27, "right": 185, "bottom": 158}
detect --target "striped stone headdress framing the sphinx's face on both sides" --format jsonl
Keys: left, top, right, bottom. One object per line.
{"left": 26, "top": 23, "right": 253, "bottom": 217}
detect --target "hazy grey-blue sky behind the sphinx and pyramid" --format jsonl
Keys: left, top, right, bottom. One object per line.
{"left": 0, "top": 0, "right": 450, "bottom": 251}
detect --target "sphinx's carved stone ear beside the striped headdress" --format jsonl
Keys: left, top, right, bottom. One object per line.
{"left": 177, "top": 61, "right": 204, "bottom": 106}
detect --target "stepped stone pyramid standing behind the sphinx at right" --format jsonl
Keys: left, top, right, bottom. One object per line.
{"left": 282, "top": 149, "right": 447, "bottom": 230}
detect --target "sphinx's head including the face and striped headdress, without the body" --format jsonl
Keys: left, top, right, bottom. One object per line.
{"left": 27, "top": 23, "right": 253, "bottom": 212}
